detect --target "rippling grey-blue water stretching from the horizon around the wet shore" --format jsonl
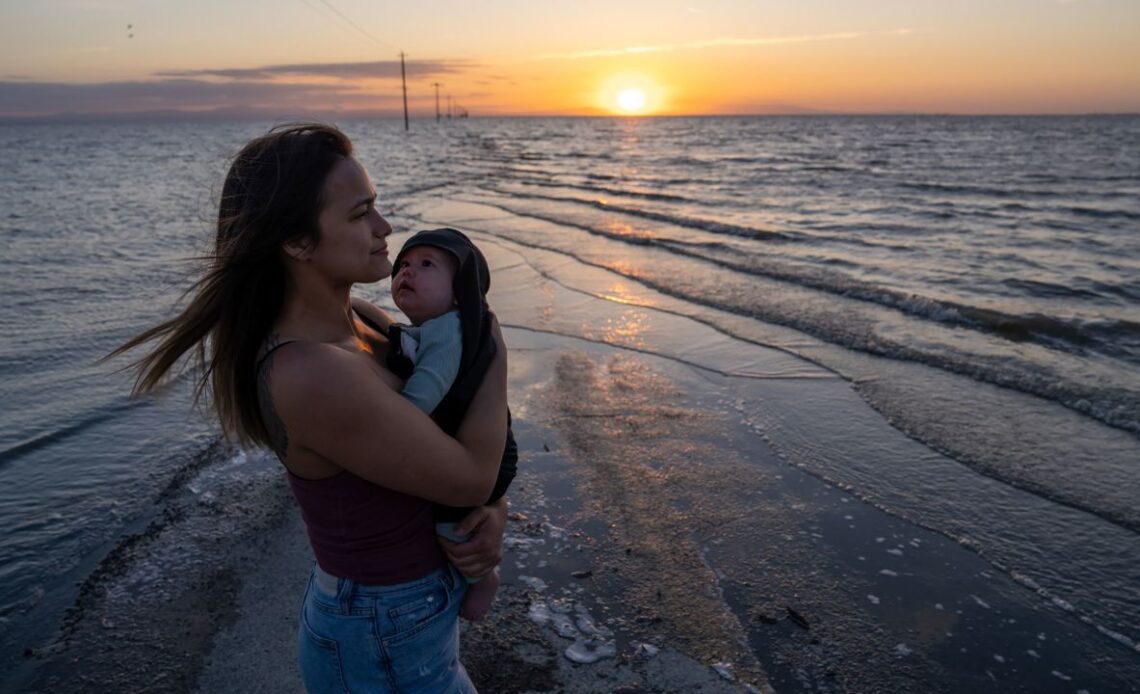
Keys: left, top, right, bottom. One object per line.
{"left": 0, "top": 117, "right": 1140, "bottom": 683}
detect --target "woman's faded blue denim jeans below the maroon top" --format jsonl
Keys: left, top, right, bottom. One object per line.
{"left": 298, "top": 564, "right": 475, "bottom": 694}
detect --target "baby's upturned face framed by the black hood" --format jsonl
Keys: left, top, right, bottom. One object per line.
{"left": 392, "top": 246, "right": 456, "bottom": 325}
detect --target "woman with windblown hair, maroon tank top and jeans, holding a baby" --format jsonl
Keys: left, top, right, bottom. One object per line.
{"left": 119, "top": 124, "right": 506, "bottom": 692}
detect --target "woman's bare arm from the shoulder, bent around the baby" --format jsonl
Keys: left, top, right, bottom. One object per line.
{"left": 270, "top": 326, "right": 506, "bottom": 506}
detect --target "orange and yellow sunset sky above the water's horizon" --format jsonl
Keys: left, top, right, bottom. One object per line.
{"left": 0, "top": 0, "right": 1140, "bottom": 117}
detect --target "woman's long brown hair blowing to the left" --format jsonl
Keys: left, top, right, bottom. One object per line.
{"left": 109, "top": 123, "right": 352, "bottom": 446}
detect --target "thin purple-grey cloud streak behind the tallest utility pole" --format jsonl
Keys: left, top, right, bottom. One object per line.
{"left": 155, "top": 60, "right": 475, "bottom": 80}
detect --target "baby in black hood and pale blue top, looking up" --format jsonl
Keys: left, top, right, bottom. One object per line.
{"left": 388, "top": 229, "right": 519, "bottom": 620}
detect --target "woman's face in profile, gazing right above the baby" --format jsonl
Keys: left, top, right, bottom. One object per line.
{"left": 309, "top": 158, "right": 392, "bottom": 284}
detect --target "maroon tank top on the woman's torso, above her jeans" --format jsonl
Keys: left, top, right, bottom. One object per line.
{"left": 288, "top": 471, "right": 446, "bottom": 586}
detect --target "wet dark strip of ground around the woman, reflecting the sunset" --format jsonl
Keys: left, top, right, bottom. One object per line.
{"left": 10, "top": 207, "right": 1138, "bottom": 694}
